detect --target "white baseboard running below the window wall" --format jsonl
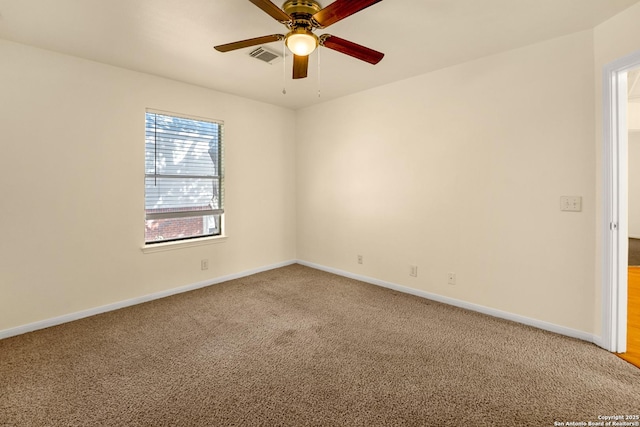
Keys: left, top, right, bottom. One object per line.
{"left": 0, "top": 260, "right": 296, "bottom": 340}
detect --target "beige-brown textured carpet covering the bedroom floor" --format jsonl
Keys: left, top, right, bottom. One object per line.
{"left": 0, "top": 265, "right": 640, "bottom": 426}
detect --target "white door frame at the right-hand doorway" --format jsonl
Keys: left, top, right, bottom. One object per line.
{"left": 598, "top": 51, "right": 640, "bottom": 353}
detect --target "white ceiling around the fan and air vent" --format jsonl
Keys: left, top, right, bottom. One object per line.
{"left": 0, "top": 0, "right": 640, "bottom": 108}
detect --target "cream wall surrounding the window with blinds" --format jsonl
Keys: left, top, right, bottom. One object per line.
{"left": 0, "top": 41, "right": 295, "bottom": 331}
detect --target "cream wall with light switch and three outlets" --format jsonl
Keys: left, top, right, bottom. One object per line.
{"left": 297, "top": 31, "right": 595, "bottom": 333}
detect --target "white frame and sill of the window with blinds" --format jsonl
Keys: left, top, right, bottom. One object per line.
{"left": 142, "top": 108, "right": 227, "bottom": 253}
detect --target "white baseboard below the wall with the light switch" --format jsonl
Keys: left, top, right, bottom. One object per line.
{"left": 298, "top": 260, "right": 597, "bottom": 342}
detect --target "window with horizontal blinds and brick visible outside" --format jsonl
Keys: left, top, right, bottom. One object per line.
{"left": 144, "top": 111, "right": 224, "bottom": 245}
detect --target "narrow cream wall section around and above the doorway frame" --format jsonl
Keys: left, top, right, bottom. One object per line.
{"left": 593, "top": 3, "right": 640, "bottom": 336}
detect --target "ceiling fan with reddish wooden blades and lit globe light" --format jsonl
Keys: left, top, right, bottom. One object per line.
{"left": 214, "top": 0, "right": 384, "bottom": 79}
